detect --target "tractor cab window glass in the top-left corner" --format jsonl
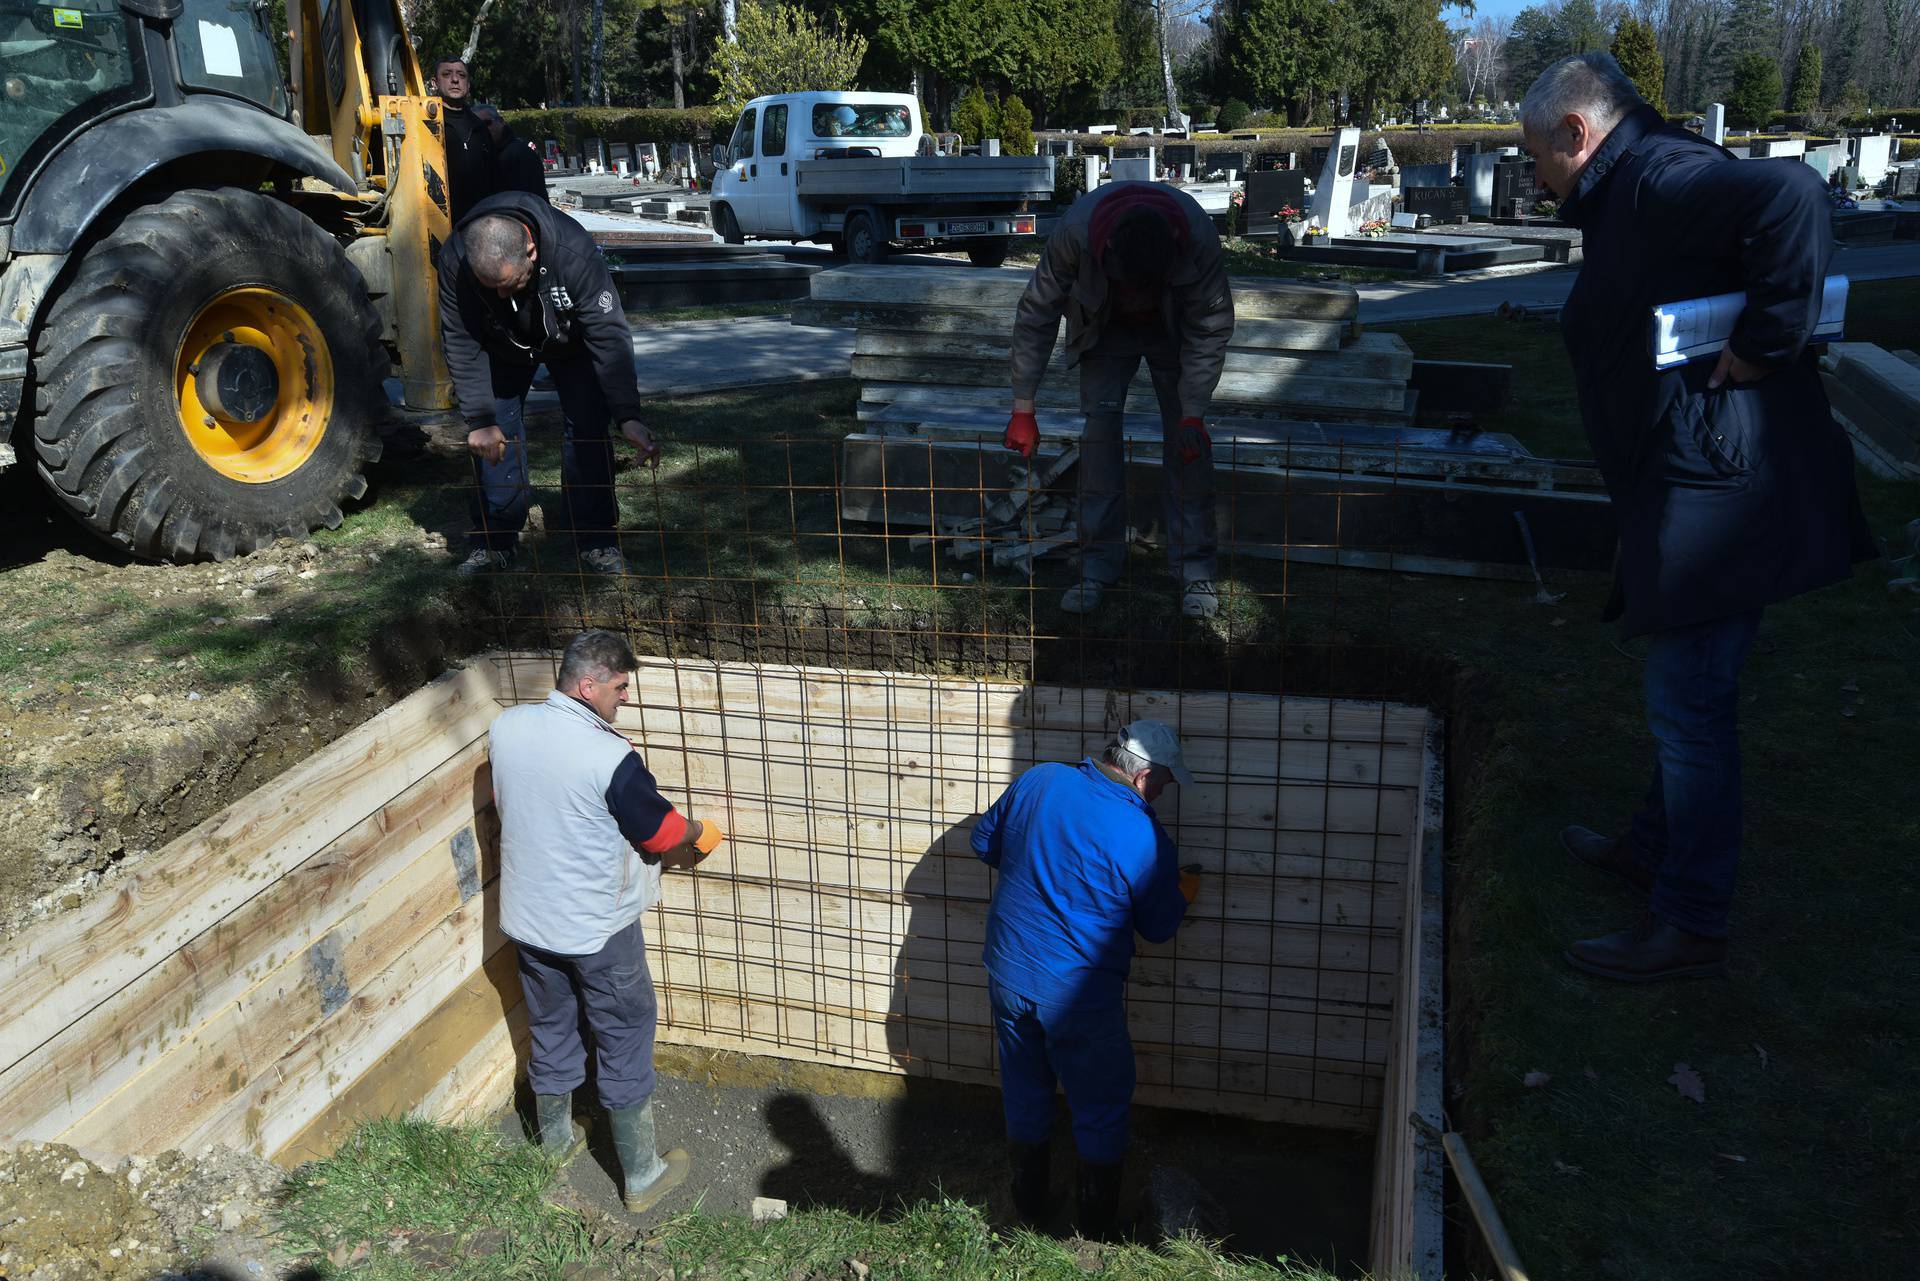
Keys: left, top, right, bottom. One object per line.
{"left": 0, "top": 0, "right": 134, "bottom": 186}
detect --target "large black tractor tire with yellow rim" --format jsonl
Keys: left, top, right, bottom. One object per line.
{"left": 33, "top": 188, "right": 388, "bottom": 561}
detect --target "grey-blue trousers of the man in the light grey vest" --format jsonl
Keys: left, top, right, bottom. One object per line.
{"left": 515, "top": 920, "right": 660, "bottom": 1110}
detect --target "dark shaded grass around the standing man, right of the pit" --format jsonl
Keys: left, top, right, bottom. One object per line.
{"left": 1396, "top": 282, "right": 1920, "bottom": 1281}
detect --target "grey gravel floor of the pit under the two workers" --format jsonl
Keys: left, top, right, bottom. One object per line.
{"left": 499, "top": 1072, "right": 1373, "bottom": 1275}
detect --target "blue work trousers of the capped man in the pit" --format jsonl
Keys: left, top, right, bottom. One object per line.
{"left": 987, "top": 978, "right": 1133, "bottom": 1166}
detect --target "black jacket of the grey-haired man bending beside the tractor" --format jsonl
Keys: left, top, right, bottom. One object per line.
{"left": 440, "top": 192, "right": 639, "bottom": 426}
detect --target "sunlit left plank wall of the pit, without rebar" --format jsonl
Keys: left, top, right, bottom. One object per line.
{"left": 0, "top": 666, "right": 518, "bottom": 1160}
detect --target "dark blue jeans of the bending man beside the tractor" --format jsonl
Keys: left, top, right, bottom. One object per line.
{"left": 468, "top": 355, "right": 618, "bottom": 551}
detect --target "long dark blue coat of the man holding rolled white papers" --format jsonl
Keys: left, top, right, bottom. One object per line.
{"left": 1561, "top": 108, "right": 1876, "bottom": 636}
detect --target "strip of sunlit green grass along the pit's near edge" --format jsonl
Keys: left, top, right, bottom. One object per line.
{"left": 280, "top": 1120, "right": 1331, "bottom": 1281}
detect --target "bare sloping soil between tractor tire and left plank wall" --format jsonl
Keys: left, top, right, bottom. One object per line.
{"left": 0, "top": 484, "right": 464, "bottom": 935}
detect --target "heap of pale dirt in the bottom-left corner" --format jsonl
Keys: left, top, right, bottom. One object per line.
{"left": 0, "top": 1143, "right": 292, "bottom": 1281}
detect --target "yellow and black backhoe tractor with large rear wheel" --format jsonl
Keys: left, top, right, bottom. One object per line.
{"left": 0, "top": 0, "right": 447, "bottom": 561}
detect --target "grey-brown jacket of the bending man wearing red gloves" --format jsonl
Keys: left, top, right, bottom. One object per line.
{"left": 1014, "top": 182, "right": 1233, "bottom": 419}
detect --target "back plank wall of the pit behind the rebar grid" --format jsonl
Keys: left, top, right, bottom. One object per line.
{"left": 501, "top": 655, "right": 1428, "bottom": 1129}
